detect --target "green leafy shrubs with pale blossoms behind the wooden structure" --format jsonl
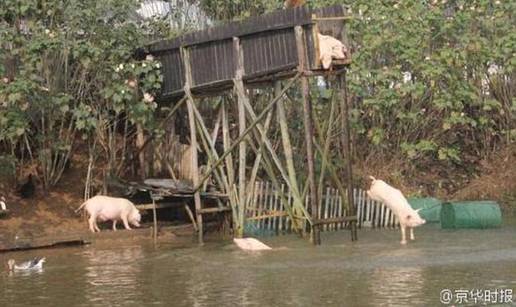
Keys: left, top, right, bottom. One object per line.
{"left": 0, "top": 0, "right": 516, "bottom": 190}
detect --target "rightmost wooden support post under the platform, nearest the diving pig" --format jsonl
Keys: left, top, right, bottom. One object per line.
{"left": 338, "top": 71, "right": 358, "bottom": 241}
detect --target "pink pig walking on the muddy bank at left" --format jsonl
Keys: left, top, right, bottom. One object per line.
{"left": 75, "top": 196, "right": 141, "bottom": 232}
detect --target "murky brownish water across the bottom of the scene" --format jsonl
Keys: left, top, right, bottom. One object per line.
{"left": 0, "top": 221, "right": 516, "bottom": 306}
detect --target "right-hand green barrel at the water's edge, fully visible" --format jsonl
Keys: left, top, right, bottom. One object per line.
{"left": 441, "top": 201, "right": 502, "bottom": 229}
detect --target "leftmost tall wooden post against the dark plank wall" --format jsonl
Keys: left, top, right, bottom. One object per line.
{"left": 181, "top": 48, "right": 204, "bottom": 244}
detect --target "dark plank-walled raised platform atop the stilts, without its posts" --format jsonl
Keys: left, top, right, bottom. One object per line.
{"left": 138, "top": 5, "right": 350, "bottom": 102}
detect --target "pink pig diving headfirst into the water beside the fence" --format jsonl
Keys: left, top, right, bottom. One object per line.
{"left": 367, "top": 176, "right": 426, "bottom": 244}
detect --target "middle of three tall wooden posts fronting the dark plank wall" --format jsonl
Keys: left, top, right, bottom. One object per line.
{"left": 233, "top": 37, "right": 249, "bottom": 237}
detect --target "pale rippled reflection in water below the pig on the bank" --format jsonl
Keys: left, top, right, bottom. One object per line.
{"left": 83, "top": 246, "right": 144, "bottom": 304}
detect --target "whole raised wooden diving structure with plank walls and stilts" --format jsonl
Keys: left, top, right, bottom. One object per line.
{"left": 140, "top": 6, "right": 356, "bottom": 244}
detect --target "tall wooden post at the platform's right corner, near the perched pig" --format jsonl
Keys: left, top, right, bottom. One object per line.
{"left": 295, "top": 26, "right": 321, "bottom": 245}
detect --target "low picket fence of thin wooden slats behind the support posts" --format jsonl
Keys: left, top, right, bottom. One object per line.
{"left": 246, "top": 182, "right": 398, "bottom": 234}
